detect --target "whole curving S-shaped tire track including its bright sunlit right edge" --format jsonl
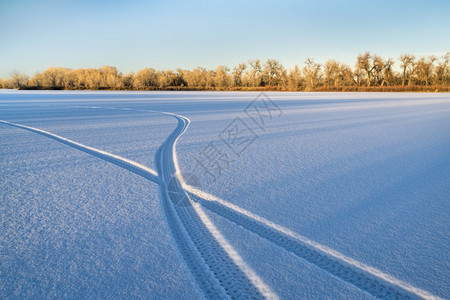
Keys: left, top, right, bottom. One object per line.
{"left": 155, "top": 113, "right": 277, "bottom": 299}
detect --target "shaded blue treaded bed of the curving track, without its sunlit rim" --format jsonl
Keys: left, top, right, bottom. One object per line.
{"left": 155, "top": 116, "right": 263, "bottom": 299}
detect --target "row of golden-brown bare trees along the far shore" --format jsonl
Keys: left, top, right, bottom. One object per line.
{"left": 0, "top": 52, "right": 450, "bottom": 91}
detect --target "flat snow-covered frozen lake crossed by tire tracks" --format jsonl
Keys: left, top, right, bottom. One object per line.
{"left": 0, "top": 91, "right": 450, "bottom": 299}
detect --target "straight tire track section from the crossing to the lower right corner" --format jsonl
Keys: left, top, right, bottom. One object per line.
{"left": 185, "top": 185, "right": 440, "bottom": 299}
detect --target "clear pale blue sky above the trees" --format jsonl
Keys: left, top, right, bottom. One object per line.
{"left": 0, "top": 0, "right": 450, "bottom": 77}
